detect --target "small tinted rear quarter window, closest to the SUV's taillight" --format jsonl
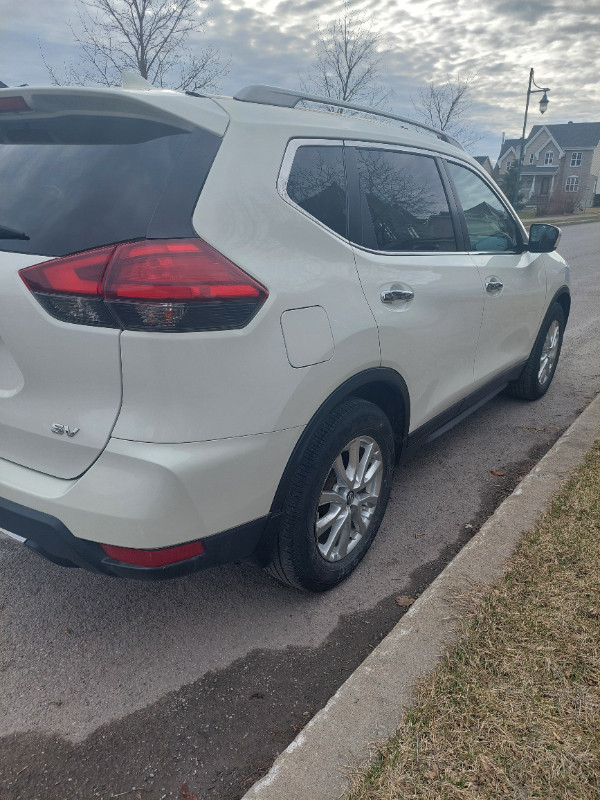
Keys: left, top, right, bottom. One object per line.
{"left": 287, "top": 145, "right": 348, "bottom": 238}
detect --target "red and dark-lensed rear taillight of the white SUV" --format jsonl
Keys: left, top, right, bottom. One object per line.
{"left": 19, "top": 239, "right": 268, "bottom": 333}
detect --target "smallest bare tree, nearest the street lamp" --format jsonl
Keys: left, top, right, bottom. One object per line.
{"left": 412, "top": 72, "right": 480, "bottom": 146}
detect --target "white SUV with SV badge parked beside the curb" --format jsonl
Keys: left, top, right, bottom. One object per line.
{"left": 0, "top": 81, "right": 570, "bottom": 591}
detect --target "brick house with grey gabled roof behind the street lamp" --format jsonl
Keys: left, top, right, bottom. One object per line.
{"left": 496, "top": 122, "right": 600, "bottom": 214}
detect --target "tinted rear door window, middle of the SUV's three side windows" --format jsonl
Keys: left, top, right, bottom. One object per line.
{"left": 356, "top": 149, "right": 456, "bottom": 252}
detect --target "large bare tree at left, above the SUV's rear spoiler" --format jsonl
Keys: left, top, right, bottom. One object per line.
{"left": 40, "top": 0, "right": 228, "bottom": 91}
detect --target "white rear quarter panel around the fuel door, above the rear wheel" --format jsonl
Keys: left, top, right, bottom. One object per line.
{"left": 113, "top": 124, "right": 380, "bottom": 442}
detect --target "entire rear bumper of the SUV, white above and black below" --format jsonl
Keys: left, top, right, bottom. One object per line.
{"left": 0, "top": 428, "right": 302, "bottom": 578}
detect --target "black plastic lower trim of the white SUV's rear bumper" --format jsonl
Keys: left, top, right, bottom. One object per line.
{"left": 0, "top": 498, "right": 277, "bottom": 580}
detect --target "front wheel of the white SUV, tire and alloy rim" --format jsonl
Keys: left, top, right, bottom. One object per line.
{"left": 506, "top": 303, "right": 565, "bottom": 400}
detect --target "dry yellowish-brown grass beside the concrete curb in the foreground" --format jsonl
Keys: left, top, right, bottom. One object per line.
{"left": 348, "top": 442, "right": 600, "bottom": 800}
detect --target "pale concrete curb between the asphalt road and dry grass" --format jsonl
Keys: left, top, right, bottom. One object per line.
{"left": 242, "top": 395, "right": 600, "bottom": 800}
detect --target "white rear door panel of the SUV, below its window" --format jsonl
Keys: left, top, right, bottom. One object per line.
{"left": 355, "top": 248, "right": 483, "bottom": 431}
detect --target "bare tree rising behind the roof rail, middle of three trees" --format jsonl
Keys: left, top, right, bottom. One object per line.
{"left": 300, "top": 1, "right": 392, "bottom": 107}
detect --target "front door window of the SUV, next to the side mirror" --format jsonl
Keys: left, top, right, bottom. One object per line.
{"left": 447, "top": 162, "right": 519, "bottom": 252}
